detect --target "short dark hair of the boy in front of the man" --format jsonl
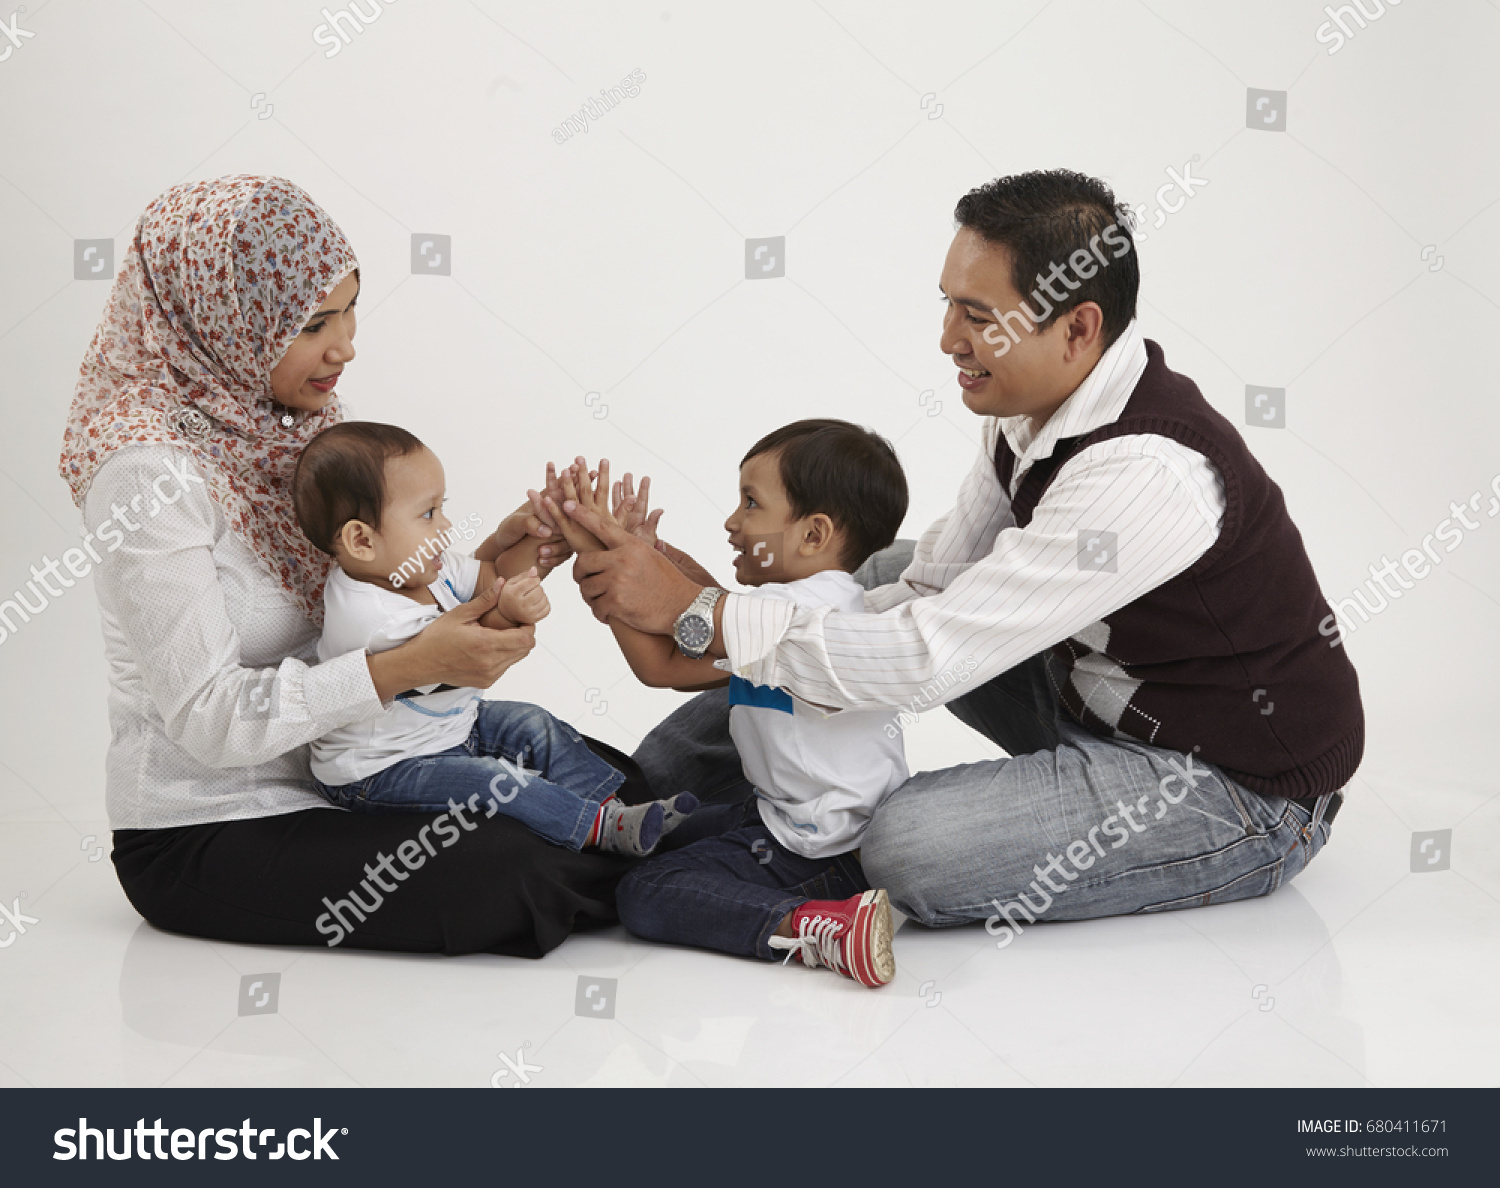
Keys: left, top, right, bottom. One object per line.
{"left": 740, "top": 420, "right": 908, "bottom": 570}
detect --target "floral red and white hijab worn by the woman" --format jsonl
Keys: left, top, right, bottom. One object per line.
{"left": 59, "top": 176, "right": 359, "bottom": 624}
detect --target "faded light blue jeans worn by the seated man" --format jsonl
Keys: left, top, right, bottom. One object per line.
{"left": 635, "top": 542, "right": 1331, "bottom": 945}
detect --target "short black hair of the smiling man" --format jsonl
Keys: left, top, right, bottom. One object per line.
{"left": 953, "top": 170, "right": 1140, "bottom": 351}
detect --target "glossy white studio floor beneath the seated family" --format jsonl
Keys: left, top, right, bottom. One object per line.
{"left": 0, "top": 753, "right": 1500, "bottom": 1088}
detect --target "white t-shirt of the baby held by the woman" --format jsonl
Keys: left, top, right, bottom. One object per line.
{"left": 311, "top": 552, "right": 483, "bottom": 786}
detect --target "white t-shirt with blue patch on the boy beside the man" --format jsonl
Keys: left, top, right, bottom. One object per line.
{"left": 716, "top": 570, "right": 909, "bottom": 858}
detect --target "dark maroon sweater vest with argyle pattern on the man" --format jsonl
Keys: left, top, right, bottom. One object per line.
{"left": 995, "top": 339, "right": 1365, "bottom": 798}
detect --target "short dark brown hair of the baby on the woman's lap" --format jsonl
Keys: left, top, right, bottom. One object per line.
{"left": 291, "top": 422, "right": 423, "bottom": 557}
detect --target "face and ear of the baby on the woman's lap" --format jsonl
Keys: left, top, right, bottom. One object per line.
{"left": 341, "top": 447, "right": 453, "bottom": 590}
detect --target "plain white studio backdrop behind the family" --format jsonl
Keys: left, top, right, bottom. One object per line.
{"left": 0, "top": 0, "right": 1500, "bottom": 846}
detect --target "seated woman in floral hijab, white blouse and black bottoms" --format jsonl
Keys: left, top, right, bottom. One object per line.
{"left": 60, "top": 177, "right": 627, "bottom": 957}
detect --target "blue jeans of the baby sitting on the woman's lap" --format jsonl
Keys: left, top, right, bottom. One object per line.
{"left": 318, "top": 701, "right": 626, "bottom": 851}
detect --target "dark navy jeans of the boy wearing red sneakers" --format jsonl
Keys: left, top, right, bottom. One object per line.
{"left": 615, "top": 800, "right": 870, "bottom": 960}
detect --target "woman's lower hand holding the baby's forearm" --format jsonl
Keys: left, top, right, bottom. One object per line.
{"left": 368, "top": 578, "right": 537, "bottom": 702}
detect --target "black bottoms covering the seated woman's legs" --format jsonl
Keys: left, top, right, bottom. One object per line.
{"left": 111, "top": 740, "right": 651, "bottom": 957}
